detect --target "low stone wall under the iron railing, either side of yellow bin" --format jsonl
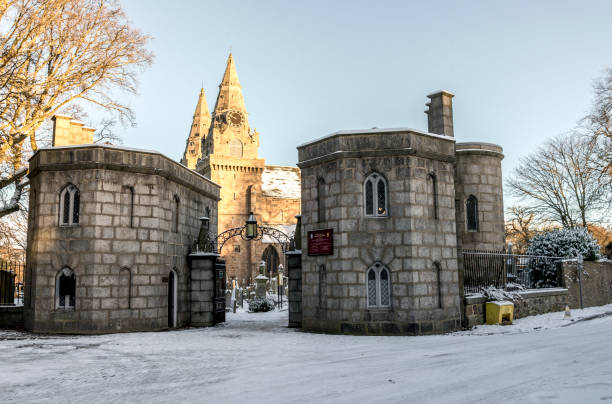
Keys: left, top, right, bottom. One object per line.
{"left": 464, "top": 288, "right": 569, "bottom": 327}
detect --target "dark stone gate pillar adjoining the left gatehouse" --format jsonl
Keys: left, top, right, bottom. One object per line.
{"left": 189, "top": 252, "right": 219, "bottom": 327}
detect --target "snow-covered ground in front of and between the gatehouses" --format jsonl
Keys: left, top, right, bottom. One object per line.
{"left": 0, "top": 305, "right": 612, "bottom": 403}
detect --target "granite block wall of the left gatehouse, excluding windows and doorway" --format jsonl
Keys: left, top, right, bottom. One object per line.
{"left": 25, "top": 146, "right": 219, "bottom": 333}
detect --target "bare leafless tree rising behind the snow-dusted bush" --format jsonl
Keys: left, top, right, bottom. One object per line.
{"left": 508, "top": 132, "right": 612, "bottom": 227}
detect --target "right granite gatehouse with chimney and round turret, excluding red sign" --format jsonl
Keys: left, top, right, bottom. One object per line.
{"left": 298, "top": 91, "right": 504, "bottom": 334}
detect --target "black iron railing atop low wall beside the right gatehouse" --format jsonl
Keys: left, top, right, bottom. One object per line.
{"left": 462, "top": 250, "right": 564, "bottom": 293}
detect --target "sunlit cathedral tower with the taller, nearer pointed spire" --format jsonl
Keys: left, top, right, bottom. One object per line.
{"left": 196, "top": 53, "right": 265, "bottom": 282}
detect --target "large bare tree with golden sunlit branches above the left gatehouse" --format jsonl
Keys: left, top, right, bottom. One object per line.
{"left": 0, "top": 0, "right": 152, "bottom": 217}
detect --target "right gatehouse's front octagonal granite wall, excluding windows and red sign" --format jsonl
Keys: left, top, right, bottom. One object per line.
{"left": 298, "top": 129, "right": 461, "bottom": 334}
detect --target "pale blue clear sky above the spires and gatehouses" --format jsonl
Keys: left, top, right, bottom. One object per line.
{"left": 116, "top": 0, "right": 612, "bottom": 202}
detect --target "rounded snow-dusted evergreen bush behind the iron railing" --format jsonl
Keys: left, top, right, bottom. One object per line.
{"left": 527, "top": 228, "right": 600, "bottom": 287}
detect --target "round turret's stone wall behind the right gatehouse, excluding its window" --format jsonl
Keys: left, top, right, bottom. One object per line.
{"left": 455, "top": 142, "right": 505, "bottom": 250}
